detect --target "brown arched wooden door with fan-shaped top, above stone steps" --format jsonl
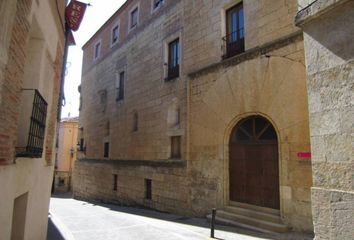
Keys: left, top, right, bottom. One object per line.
{"left": 229, "top": 116, "right": 279, "bottom": 209}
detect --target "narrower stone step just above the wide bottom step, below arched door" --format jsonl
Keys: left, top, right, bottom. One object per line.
{"left": 224, "top": 206, "right": 282, "bottom": 224}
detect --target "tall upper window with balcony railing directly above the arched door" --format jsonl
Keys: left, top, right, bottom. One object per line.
{"left": 223, "top": 3, "right": 245, "bottom": 58}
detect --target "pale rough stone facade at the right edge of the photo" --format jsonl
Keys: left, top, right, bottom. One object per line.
{"left": 296, "top": 1, "right": 354, "bottom": 239}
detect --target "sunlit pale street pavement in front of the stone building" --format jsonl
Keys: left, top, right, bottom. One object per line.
{"left": 48, "top": 195, "right": 312, "bottom": 240}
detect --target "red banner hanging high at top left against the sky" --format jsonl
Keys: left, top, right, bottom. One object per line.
{"left": 65, "top": 0, "right": 87, "bottom": 31}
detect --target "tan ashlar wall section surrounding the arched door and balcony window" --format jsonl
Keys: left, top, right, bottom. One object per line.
{"left": 184, "top": 1, "right": 312, "bottom": 231}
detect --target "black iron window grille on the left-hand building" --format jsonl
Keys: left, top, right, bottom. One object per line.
{"left": 16, "top": 90, "right": 48, "bottom": 158}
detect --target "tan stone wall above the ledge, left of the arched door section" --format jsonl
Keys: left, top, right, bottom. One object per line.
{"left": 80, "top": 1, "right": 187, "bottom": 160}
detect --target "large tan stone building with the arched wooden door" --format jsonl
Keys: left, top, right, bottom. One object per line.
{"left": 74, "top": 0, "right": 313, "bottom": 232}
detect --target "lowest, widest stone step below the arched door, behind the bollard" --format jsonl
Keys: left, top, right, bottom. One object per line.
{"left": 207, "top": 210, "right": 288, "bottom": 233}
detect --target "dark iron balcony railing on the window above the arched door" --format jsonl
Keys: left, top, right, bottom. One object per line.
{"left": 222, "top": 28, "right": 245, "bottom": 59}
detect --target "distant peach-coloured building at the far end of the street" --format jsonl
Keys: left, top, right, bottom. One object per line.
{"left": 54, "top": 118, "right": 79, "bottom": 192}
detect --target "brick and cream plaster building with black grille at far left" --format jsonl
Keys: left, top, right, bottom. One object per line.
{"left": 0, "top": 0, "right": 65, "bottom": 239}
